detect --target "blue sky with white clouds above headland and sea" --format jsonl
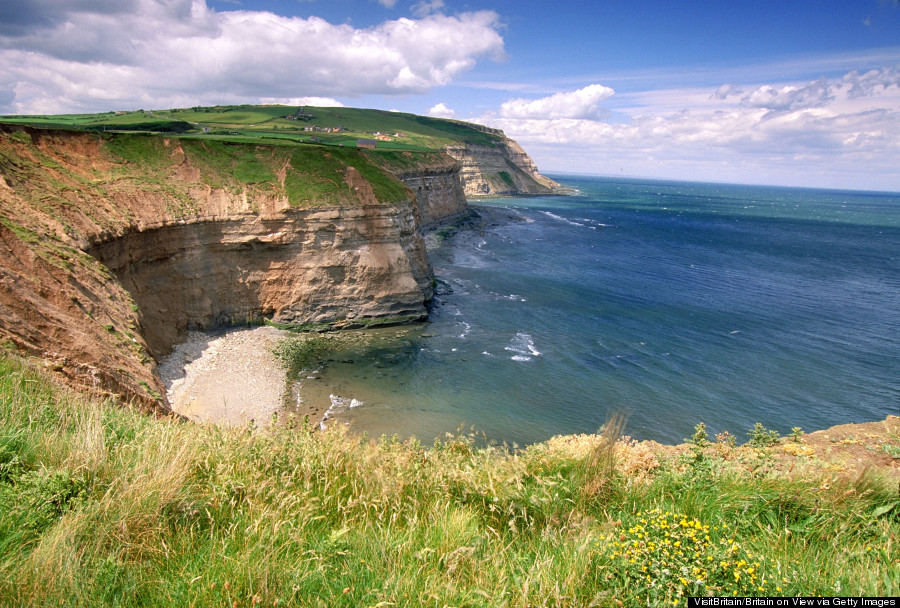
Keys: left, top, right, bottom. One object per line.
{"left": 0, "top": 0, "right": 900, "bottom": 192}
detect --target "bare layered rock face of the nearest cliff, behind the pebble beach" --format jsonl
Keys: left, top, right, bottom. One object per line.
{"left": 88, "top": 205, "right": 432, "bottom": 356}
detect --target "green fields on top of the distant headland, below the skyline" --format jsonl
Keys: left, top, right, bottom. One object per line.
{"left": 0, "top": 105, "right": 499, "bottom": 150}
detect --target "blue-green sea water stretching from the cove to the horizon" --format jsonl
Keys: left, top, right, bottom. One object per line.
{"left": 292, "top": 176, "right": 900, "bottom": 445}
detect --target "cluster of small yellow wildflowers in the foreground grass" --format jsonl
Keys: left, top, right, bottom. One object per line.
{"left": 607, "top": 509, "right": 775, "bottom": 604}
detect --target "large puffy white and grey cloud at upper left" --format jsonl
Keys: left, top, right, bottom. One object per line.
{"left": 0, "top": 0, "right": 503, "bottom": 113}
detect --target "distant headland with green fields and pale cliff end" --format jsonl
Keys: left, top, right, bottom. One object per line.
{"left": 0, "top": 105, "right": 559, "bottom": 196}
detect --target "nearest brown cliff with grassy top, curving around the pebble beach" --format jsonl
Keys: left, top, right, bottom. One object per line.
{"left": 0, "top": 126, "right": 446, "bottom": 411}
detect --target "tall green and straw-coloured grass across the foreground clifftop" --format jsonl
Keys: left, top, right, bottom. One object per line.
{"left": 0, "top": 355, "right": 900, "bottom": 607}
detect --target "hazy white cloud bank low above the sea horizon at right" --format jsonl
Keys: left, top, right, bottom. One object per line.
{"left": 479, "top": 67, "right": 900, "bottom": 191}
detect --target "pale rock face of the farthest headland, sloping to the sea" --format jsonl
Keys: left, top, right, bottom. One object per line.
{"left": 444, "top": 127, "right": 559, "bottom": 196}
